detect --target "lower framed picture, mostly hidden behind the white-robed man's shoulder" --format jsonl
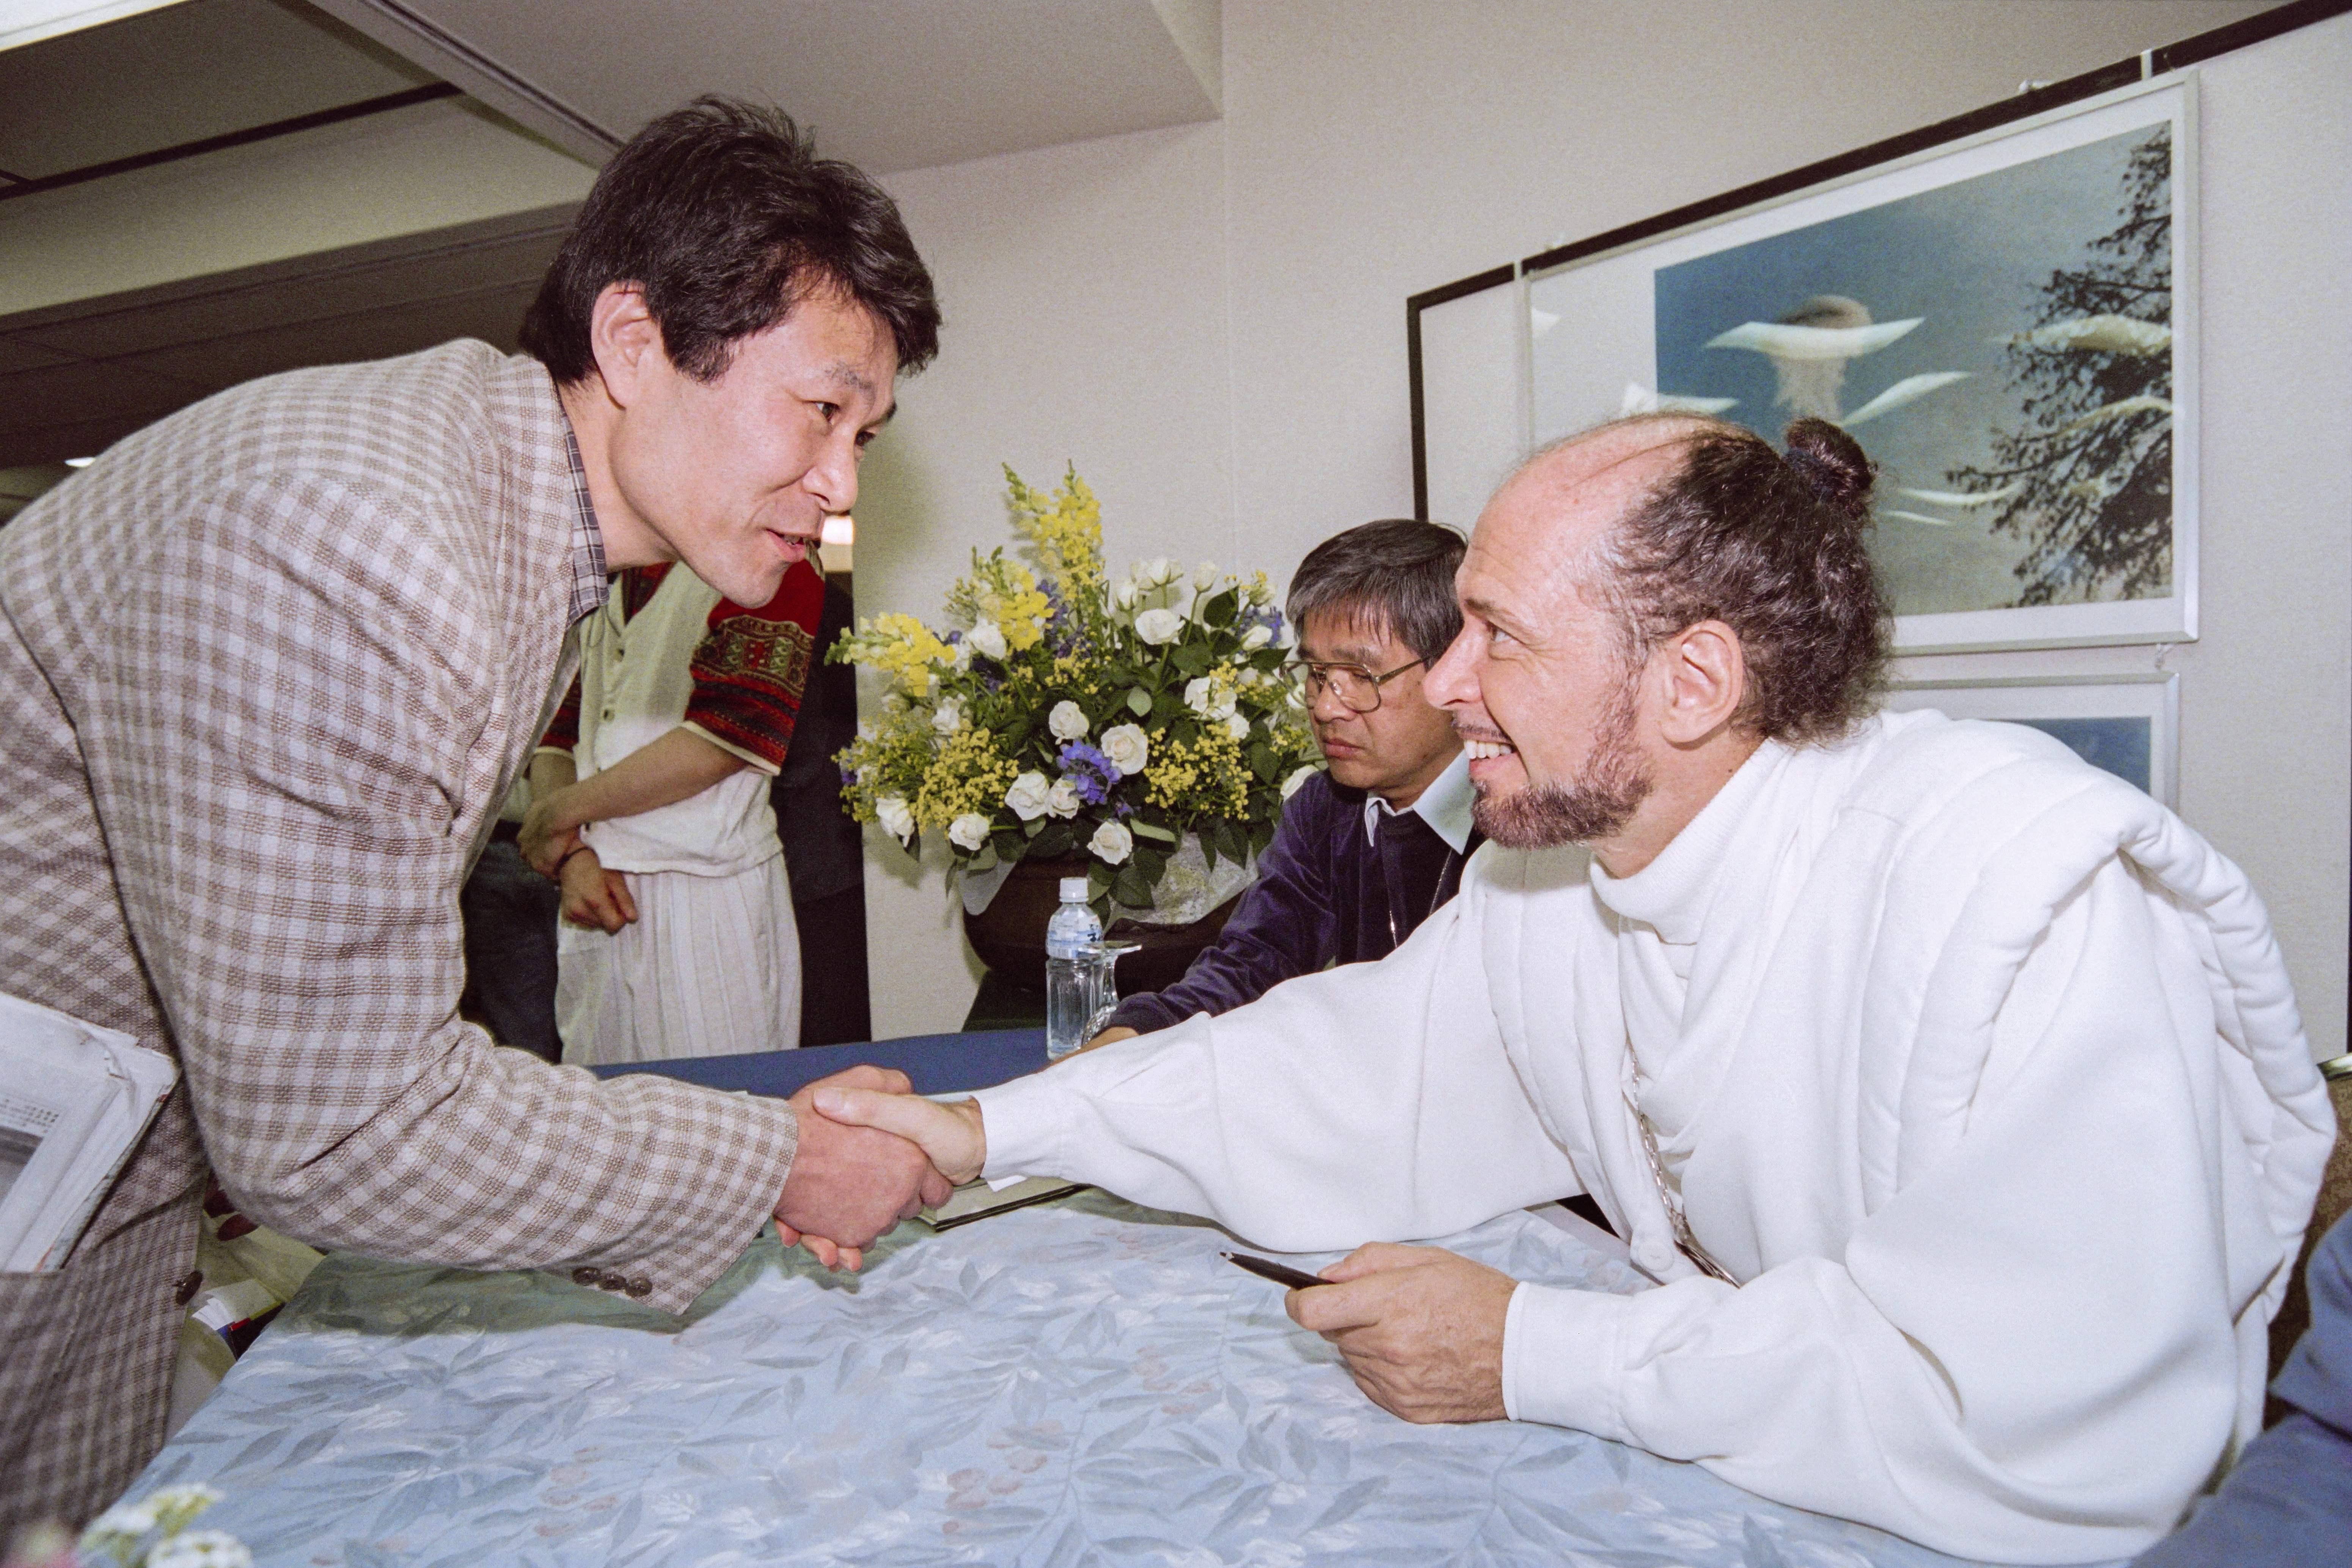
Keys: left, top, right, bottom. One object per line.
{"left": 1886, "top": 672, "right": 2180, "bottom": 806}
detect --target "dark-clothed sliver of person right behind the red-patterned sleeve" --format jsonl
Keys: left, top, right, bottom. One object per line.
{"left": 769, "top": 571, "right": 875, "bottom": 1046}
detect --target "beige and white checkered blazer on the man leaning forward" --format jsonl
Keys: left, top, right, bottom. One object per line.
{"left": 0, "top": 343, "right": 795, "bottom": 1540}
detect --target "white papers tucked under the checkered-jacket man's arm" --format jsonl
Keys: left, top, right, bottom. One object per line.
{"left": 0, "top": 992, "right": 179, "bottom": 1274}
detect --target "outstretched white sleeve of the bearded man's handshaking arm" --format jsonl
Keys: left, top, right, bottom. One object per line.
{"left": 976, "top": 891, "right": 1581, "bottom": 1251}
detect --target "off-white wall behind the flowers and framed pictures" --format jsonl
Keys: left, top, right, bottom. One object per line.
{"left": 856, "top": 0, "right": 2352, "bottom": 1051}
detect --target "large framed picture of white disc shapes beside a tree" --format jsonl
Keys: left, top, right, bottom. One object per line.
{"left": 1524, "top": 78, "right": 2197, "bottom": 654}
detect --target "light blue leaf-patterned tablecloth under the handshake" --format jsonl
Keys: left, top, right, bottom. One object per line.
{"left": 129, "top": 1194, "right": 2022, "bottom": 1568}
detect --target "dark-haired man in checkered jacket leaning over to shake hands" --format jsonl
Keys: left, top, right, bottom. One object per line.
{"left": 0, "top": 101, "right": 946, "bottom": 1540}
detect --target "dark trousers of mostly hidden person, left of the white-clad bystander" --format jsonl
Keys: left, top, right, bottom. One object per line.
{"left": 456, "top": 783, "right": 564, "bottom": 1062}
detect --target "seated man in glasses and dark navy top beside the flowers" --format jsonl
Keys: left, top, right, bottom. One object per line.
{"left": 1091, "top": 520, "right": 1479, "bottom": 1046}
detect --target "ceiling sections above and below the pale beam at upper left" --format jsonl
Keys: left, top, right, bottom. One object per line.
{"left": 0, "top": 0, "right": 1218, "bottom": 465}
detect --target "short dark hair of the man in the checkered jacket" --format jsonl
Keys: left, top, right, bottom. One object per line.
{"left": 520, "top": 99, "right": 938, "bottom": 385}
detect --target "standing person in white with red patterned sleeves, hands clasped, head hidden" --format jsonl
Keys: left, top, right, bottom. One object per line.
{"left": 520, "top": 559, "right": 826, "bottom": 1067}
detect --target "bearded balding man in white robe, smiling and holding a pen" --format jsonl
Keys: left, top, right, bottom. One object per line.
{"left": 816, "top": 416, "right": 2333, "bottom": 1563}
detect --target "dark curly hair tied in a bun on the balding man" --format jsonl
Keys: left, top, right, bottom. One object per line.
{"left": 1602, "top": 418, "right": 1886, "bottom": 743}
